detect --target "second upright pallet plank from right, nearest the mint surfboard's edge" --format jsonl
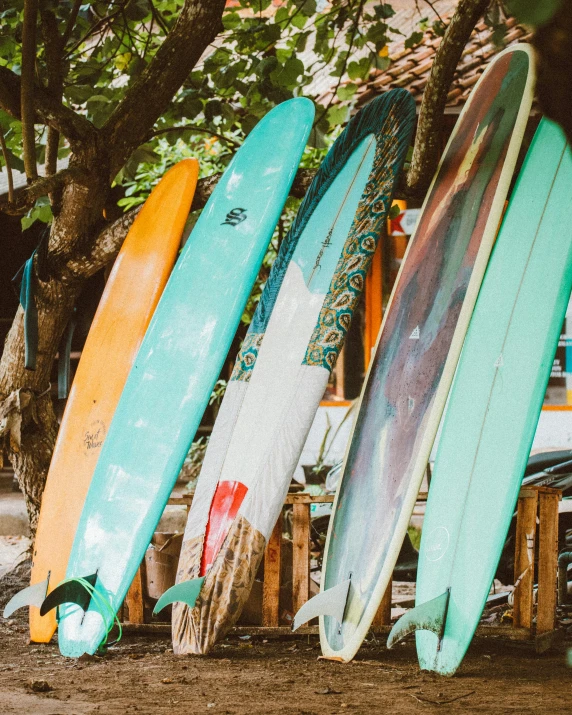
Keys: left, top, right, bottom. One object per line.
{"left": 513, "top": 490, "right": 538, "bottom": 629}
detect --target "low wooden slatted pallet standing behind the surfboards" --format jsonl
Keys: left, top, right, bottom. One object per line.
{"left": 124, "top": 487, "right": 561, "bottom": 652}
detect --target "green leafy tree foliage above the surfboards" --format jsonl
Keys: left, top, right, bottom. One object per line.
{"left": 0, "top": 0, "right": 434, "bottom": 225}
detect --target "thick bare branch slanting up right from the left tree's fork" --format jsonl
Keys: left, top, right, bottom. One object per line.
{"left": 102, "top": 0, "right": 225, "bottom": 178}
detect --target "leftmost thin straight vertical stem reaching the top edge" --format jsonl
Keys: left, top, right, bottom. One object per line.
{"left": 20, "top": 0, "right": 38, "bottom": 182}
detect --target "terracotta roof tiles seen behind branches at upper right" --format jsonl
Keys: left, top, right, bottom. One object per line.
{"left": 357, "top": 12, "right": 530, "bottom": 112}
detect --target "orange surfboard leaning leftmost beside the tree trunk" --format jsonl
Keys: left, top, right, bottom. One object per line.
{"left": 30, "top": 159, "right": 198, "bottom": 643}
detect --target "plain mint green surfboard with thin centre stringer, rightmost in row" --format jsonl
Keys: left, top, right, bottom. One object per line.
{"left": 388, "top": 120, "right": 572, "bottom": 675}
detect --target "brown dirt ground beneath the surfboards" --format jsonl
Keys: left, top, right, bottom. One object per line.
{"left": 0, "top": 565, "right": 572, "bottom": 715}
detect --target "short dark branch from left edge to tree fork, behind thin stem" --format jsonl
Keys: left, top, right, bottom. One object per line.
{"left": 0, "top": 65, "right": 97, "bottom": 150}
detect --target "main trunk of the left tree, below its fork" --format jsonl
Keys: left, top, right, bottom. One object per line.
{"left": 0, "top": 167, "right": 107, "bottom": 535}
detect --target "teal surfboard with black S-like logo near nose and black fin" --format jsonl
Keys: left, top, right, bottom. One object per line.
{"left": 50, "top": 98, "right": 314, "bottom": 657}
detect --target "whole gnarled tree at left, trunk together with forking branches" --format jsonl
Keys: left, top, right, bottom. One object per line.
{"left": 0, "top": 0, "right": 225, "bottom": 533}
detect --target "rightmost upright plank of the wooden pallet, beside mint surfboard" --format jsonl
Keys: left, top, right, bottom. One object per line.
{"left": 536, "top": 492, "right": 559, "bottom": 635}
